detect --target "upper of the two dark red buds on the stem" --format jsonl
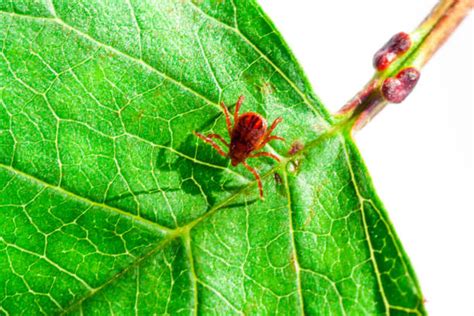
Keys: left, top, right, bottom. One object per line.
{"left": 373, "top": 32, "right": 411, "bottom": 71}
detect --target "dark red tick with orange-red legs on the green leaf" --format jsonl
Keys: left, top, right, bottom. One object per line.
{"left": 194, "top": 96, "right": 284, "bottom": 199}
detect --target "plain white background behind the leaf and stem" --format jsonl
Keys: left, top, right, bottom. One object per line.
{"left": 259, "top": 0, "right": 474, "bottom": 315}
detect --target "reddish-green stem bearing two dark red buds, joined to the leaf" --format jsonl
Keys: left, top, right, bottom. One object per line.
{"left": 335, "top": 0, "right": 474, "bottom": 131}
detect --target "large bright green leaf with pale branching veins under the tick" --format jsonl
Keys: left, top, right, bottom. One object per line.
{"left": 0, "top": 0, "right": 424, "bottom": 315}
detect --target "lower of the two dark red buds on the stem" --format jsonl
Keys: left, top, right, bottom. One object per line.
{"left": 382, "top": 67, "right": 420, "bottom": 103}
